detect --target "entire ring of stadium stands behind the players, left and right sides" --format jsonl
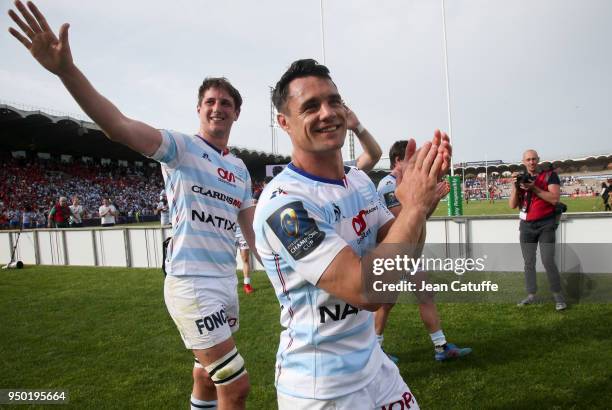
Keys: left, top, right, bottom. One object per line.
{"left": 0, "top": 104, "right": 612, "bottom": 229}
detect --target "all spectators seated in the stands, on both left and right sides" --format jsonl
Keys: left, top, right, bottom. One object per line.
{"left": 0, "top": 152, "right": 600, "bottom": 229}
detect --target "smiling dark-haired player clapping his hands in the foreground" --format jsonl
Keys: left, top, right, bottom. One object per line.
{"left": 254, "top": 60, "right": 451, "bottom": 410}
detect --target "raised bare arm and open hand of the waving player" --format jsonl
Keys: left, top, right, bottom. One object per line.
{"left": 9, "top": 0, "right": 162, "bottom": 156}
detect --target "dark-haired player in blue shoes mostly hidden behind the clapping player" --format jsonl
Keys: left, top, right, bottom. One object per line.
{"left": 375, "top": 140, "right": 472, "bottom": 361}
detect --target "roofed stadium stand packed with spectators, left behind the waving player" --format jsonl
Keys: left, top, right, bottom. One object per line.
{"left": 0, "top": 104, "right": 290, "bottom": 229}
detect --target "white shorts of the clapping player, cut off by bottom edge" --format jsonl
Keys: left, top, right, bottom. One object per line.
{"left": 276, "top": 356, "right": 419, "bottom": 410}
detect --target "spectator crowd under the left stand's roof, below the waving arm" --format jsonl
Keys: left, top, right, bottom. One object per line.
{"left": 0, "top": 153, "right": 163, "bottom": 228}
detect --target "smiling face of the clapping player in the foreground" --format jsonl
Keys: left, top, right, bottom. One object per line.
{"left": 277, "top": 76, "right": 346, "bottom": 153}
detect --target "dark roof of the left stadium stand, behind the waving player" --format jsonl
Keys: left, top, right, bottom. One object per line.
{"left": 0, "top": 104, "right": 291, "bottom": 170}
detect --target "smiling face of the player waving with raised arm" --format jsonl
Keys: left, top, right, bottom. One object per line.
{"left": 197, "top": 87, "right": 240, "bottom": 143}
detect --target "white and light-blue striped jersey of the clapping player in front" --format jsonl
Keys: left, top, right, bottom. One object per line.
{"left": 253, "top": 164, "right": 393, "bottom": 400}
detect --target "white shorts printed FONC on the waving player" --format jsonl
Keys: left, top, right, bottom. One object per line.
{"left": 164, "top": 275, "right": 239, "bottom": 349}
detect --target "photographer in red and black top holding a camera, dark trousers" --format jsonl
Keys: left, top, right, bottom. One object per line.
{"left": 509, "top": 150, "right": 567, "bottom": 310}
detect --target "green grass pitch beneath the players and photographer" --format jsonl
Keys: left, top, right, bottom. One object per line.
{"left": 0, "top": 266, "right": 612, "bottom": 409}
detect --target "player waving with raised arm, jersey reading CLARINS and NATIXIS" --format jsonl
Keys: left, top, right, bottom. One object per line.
{"left": 9, "top": 0, "right": 255, "bottom": 409}
